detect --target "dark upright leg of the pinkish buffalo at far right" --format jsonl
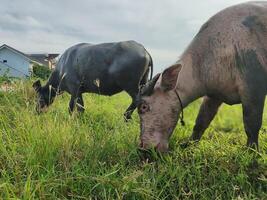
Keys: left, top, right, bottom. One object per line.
{"left": 242, "top": 95, "right": 265, "bottom": 149}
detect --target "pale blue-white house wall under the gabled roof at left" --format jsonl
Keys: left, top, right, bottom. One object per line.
{"left": 0, "top": 48, "right": 30, "bottom": 77}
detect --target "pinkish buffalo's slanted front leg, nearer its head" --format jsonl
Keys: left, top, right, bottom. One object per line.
{"left": 191, "top": 97, "right": 222, "bottom": 141}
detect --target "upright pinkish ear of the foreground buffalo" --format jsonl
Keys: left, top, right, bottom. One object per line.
{"left": 160, "top": 64, "right": 182, "bottom": 91}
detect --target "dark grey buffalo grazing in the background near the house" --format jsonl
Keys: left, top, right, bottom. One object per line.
{"left": 33, "top": 41, "right": 153, "bottom": 120}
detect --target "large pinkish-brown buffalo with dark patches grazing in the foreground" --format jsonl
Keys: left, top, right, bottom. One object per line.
{"left": 138, "top": 2, "right": 267, "bottom": 152}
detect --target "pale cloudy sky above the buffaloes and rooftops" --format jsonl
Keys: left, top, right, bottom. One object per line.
{"left": 0, "top": 0, "right": 250, "bottom": 72}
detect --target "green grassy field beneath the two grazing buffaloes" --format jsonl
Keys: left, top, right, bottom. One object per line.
{"left": 0, "top": 81, "right": 267, "bottom": 200}
